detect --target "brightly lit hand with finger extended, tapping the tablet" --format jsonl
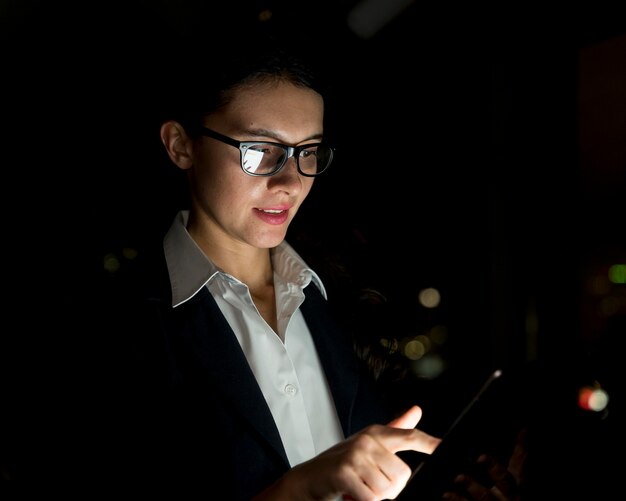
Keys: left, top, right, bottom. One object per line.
{"left": 250, "top": 406, "right": 441, "bottom": 501}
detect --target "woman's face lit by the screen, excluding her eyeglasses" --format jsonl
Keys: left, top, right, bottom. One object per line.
{"left": 189, "top": 82, "right": 324, "bottom": 252}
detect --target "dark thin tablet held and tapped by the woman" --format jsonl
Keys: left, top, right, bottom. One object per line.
{"left": 396, "top": 369, "right": 507, "bottom": 501}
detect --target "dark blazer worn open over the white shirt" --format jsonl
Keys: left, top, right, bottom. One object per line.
{"left": 101, "top": 244, "right": 391, "bottom": 500}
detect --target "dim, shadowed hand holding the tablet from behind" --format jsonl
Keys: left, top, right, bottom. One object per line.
{"left": 443, "top": 430, "right": 527, "bottom": 501}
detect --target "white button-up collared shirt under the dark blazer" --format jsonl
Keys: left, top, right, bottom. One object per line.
{"left": 163, "top": 211, "right": 344, "bottom": 466}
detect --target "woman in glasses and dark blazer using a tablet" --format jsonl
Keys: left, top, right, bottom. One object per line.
{"left": 106, "top": 30, "right": 520, "bottom": 500}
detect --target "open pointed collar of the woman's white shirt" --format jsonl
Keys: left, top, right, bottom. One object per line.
{"left": 163, "top": 210, "right": 327, "bottom": 307}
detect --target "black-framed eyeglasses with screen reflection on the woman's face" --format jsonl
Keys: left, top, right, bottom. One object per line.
{"left": 199, "top": 127, "right": 335, "bottom": 177}
